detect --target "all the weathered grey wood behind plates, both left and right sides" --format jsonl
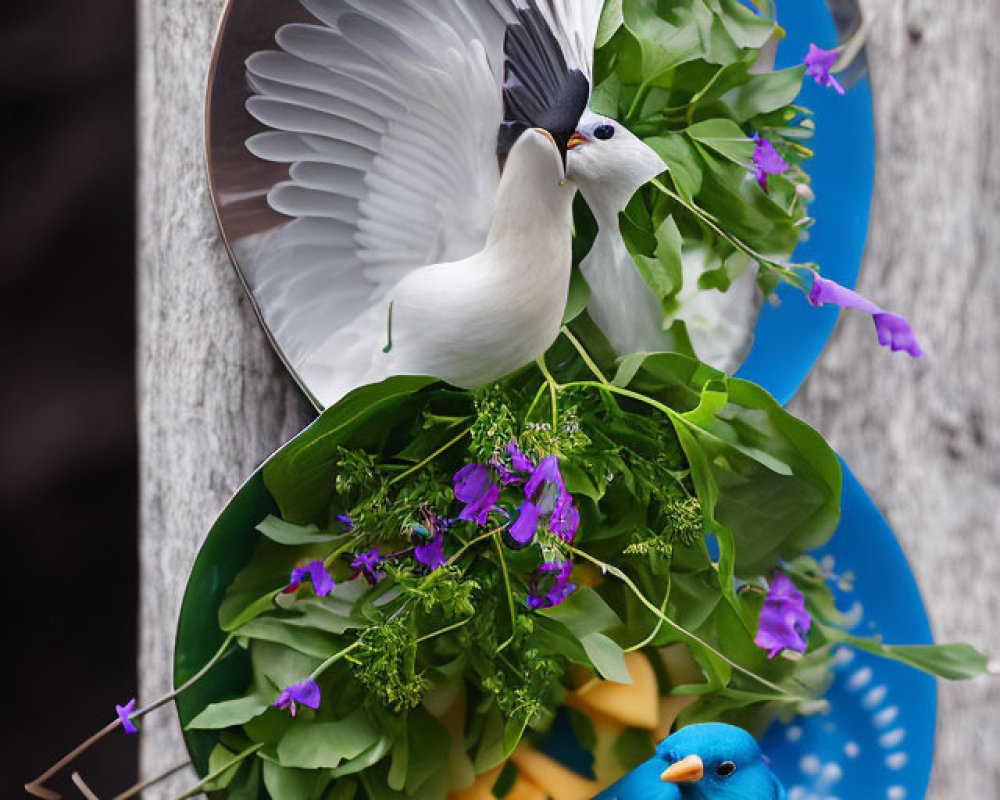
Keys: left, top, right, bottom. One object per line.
{"left": 138, "top": 0, "right": 1000, "bottom": 800}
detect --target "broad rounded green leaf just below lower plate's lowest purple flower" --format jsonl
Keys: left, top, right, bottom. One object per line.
{"left": 277, "top": 709, "right": 379, "bottom": 769}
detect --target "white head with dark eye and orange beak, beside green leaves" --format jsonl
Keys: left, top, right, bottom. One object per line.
{"left": 566, "top": 109, "right": 667, "bottom": 222}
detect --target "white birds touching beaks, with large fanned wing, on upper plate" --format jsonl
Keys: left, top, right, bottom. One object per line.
{"left": 246, "top": 0, "right": 752, "bottom": 406}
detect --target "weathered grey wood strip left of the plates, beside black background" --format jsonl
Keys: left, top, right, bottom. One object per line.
{"left": 138, "top": 0, "right": 307, "bottom": 798}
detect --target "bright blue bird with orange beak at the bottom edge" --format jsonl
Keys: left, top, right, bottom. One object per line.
{"left": 594, "top": 723, "right": 787, "bottom": 800}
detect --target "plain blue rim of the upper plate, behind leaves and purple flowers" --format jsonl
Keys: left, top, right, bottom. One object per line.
{"left": 737, "top": 0, "right": 875, "bottom": 403}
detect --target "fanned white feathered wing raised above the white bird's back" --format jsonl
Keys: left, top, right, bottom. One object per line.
{"left": 244, "top": 0, "right": 602, "bottom": 380}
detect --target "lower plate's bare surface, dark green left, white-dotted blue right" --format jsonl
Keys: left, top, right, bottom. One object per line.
{"left": 174, "top": 456, "right": 937, "bottom": 800}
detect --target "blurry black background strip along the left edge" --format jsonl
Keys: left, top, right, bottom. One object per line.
{"left": 0, "top": 0, "right": 138, "bottom": 798}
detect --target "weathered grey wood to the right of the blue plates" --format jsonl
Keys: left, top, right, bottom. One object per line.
{"left": 792, "top": 0, "right": 1000, "bottom": 800}
